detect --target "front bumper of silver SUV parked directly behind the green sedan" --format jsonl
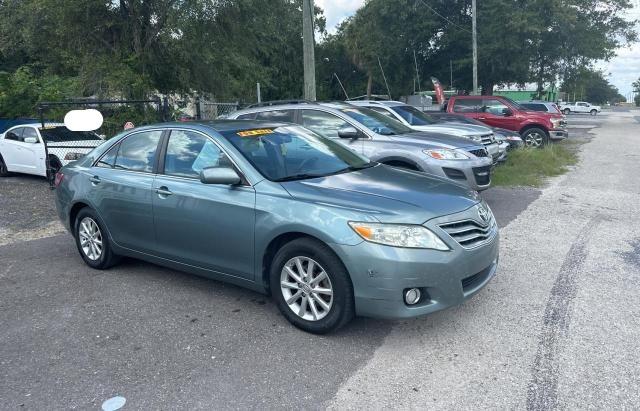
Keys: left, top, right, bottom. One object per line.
{"left": 424, "top": 157, "right": 493, "bottom": 191}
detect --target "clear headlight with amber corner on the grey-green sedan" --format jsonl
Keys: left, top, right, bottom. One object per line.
{"left": 349, "top": 222, "right": 449, "bottom": 251}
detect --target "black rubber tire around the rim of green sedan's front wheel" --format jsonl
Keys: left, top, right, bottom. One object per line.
{"left": 269, "top": 238, "right": 355, "bottom": 334}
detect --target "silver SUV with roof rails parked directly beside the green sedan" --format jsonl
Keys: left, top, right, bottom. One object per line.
{"left": 229, "top": 102, "right": 493, "bottom": 191}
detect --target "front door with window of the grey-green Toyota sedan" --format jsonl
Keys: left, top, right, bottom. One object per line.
{"left": 153, "top": 130, "right": 256, "bottom": 280}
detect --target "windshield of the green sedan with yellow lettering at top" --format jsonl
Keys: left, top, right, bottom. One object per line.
{"left": 222, "top": 126, "right": 374, "bottom": 181}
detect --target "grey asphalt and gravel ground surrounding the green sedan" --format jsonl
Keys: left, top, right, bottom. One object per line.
{"left": 0, "top": 112, "right": 640, "bottom": 409}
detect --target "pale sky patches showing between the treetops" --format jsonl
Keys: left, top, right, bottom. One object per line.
{"left": 315, "top": 0, "right": 640, "bottom": 100}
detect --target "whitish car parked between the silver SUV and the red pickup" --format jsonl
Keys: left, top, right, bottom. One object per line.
{"left": 348, "top": 100, "right": 502, "bottom": 161}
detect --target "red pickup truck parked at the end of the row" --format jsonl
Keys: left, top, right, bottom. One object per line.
{"left": 445, "top": 96, "right": 569, "bottom": 147}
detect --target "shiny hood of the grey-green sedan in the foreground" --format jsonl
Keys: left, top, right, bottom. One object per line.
{"left": 281, "top": 164, "right": 479, "bottom": 224}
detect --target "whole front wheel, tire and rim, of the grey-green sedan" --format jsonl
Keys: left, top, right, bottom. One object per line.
{"left": 270, "top": 238, "right": 355, "bottom": 334}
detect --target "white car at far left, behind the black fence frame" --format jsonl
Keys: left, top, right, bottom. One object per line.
{"left": 0, "top": 123, "right": 104, "bottom": 177}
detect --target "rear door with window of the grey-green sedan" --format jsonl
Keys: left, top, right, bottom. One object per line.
{"left": 89, "top": 130, "right": 163, "bottom": 253}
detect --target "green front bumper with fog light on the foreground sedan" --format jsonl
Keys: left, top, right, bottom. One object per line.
{"left": 332, "top": 206, "right": 499, "bottom": 319}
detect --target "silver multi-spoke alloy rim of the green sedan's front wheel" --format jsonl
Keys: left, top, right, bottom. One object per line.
{"left": 280, "top": 256, "right": 333, "bottom": 321}
